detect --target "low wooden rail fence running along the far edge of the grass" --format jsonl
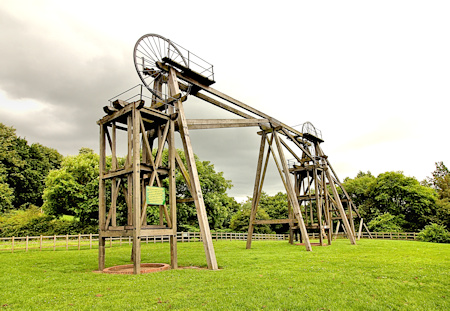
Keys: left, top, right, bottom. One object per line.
{"left": 0, "top": 232, "right": 417, "bottom": 252}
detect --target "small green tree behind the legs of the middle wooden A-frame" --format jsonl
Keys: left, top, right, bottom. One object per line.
{"left": 230, "top": 202, "right": 273, "bottom": 233}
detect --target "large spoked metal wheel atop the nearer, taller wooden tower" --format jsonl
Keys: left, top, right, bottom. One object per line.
{"left": 133, "top": 34, "right": 188, "bottom": 101}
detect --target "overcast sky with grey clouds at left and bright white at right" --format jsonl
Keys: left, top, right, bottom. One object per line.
{"left": 0, "top": 0, "right": 450, "bottom": 198}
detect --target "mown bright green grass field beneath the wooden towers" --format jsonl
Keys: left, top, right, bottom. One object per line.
{"left": 0, "top": 240, "right": 450, "bottom": 310}
